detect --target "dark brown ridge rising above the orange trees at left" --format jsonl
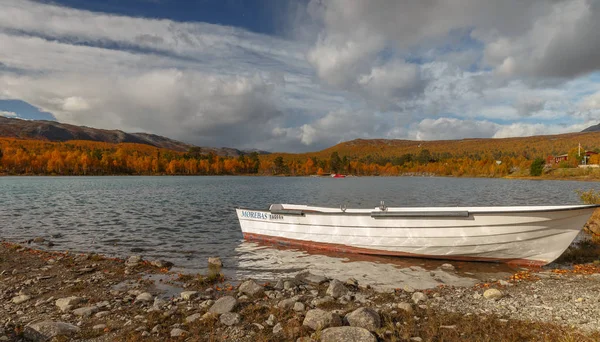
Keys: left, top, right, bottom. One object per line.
{"left": 0, "top": 116, "right": 268, "bottom": 157}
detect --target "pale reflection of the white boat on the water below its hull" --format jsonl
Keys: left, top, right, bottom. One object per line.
{"left": 235, "top": 241, "right": 515, "bottom": 290}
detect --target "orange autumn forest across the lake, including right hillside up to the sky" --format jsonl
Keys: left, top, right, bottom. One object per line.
{"left": 0, "top": 133, "right": 600, "bottom": 177}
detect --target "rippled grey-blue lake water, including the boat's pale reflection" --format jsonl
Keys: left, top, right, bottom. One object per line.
{"left": 0, "top": 177, "right": 599, "bottom": 288}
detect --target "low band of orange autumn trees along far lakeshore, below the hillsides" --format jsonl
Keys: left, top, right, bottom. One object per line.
{"left": 0, "top": 138, "right": 596, "bottom": 177}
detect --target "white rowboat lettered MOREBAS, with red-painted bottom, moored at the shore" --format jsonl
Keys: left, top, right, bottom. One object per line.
{"left": 236, "top": 202, "right": 599, "bottom": 266}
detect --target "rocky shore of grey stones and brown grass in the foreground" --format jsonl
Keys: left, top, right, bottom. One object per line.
{"left": 0, "top": 242, "right": 600, "bottom": 342}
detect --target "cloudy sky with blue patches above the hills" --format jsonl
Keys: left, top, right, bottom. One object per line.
{"left": 0, "top": 0, "right": 600, "bottom": 152}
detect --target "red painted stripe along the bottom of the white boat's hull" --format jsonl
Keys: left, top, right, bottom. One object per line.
{"left": 243, "top": 233, "right": 547, "bottom": 267}
